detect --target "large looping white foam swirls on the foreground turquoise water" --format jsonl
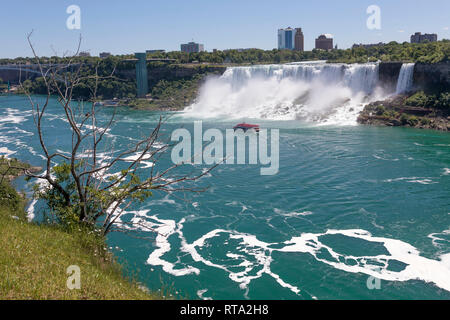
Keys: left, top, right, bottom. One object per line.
{"left": 139, "top": 217, "right": 450, "bottom": 295}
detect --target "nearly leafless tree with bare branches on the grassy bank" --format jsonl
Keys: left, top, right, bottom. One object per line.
{"left": 21, "top": 33, "right": 216, "bottom": 235}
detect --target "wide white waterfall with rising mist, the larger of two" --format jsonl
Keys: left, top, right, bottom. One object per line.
{"left": 185, "top": 62, "right": 379, "bottom": 123}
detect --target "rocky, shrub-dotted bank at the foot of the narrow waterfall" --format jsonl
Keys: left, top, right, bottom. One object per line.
{"left": 358, "top": 92, "right": 450, "bottom": 131}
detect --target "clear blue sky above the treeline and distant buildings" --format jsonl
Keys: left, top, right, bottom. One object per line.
{"left": 0, "top": 0, "right": 450, "bottom": 58}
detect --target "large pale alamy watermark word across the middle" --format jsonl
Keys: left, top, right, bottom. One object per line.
{"left": 171, "top": 121, "right": 280, "bottom": 176}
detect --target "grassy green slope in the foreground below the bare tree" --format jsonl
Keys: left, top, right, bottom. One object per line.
{"left": 0, "top": 158, "right": 163, "bottom": 300}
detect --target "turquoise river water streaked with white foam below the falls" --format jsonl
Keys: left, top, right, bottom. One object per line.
{"left": 0, "top": 96, "right": 450, "bottom": 299}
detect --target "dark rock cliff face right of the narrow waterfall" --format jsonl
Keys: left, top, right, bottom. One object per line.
{"left": 414, "top": 61, "right": 450, "bottom": 92}
